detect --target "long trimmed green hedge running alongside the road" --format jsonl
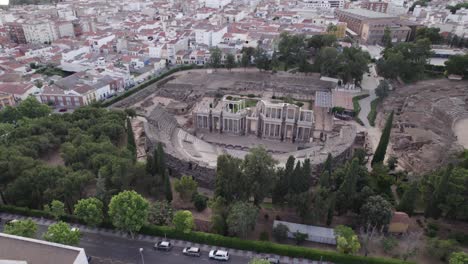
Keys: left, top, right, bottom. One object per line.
{"left": 0, "top": 205, "right": 411, "bottom": 264}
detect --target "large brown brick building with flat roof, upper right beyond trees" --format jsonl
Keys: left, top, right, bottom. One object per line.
{"left": 335, "top": 9, "right": 411, "bottom": 45}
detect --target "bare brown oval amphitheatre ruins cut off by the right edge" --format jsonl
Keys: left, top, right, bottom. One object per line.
{"left": 376, "top": 79, "right": 468, "bottom": 174}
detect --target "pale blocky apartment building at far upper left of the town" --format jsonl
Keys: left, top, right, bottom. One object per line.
{"left": 23, "top": 20, "right": 58, "bottom": 43}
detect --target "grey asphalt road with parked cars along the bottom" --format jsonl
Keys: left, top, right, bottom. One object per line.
{"left": 0, "top": 213, "right": 330, "bottom": 264}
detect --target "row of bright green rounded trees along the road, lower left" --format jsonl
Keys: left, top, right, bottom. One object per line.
{"left": 4, "top": 191, "right": 195, "bottom": 245}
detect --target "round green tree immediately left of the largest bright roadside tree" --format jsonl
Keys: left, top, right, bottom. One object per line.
{"left": 75, "top": 197, "right": 104, "bottom": 226}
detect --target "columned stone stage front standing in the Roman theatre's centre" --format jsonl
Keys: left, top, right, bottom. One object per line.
{"left": 193, "top": 96, "right": 314, "bottom": 142}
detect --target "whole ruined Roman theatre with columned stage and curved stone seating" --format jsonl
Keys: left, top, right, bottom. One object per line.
{"left": 112, "top": 70, "right": 357, "bottom": 186}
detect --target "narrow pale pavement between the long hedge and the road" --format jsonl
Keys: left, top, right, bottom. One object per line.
{"left": 0, "top": 213, "right": 332, "bottom": 264}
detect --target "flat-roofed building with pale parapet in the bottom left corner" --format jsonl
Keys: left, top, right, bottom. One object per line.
{"left": 0, "top": 233, "right": 88, "bottom": 264}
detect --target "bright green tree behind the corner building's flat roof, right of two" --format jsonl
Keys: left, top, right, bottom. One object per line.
{"left": 44, "top": 221, "right": 81, "bottom": 246}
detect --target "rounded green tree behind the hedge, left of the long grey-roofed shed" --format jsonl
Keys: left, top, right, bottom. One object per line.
{"left": 226, "top": 202, "right": 258, "bottom": 238}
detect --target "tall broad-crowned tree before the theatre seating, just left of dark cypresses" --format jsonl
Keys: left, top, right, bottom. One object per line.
{"left": 243, "top": 147, "right": 277, "bottom": 205}
